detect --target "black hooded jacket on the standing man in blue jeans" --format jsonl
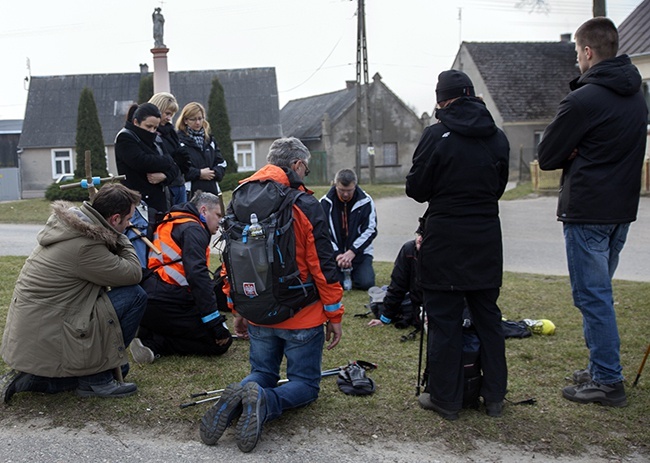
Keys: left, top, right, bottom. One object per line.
{"left": 538, "top": 55, "right": 648, "bottom": 224}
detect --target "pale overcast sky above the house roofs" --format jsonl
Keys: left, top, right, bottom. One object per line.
{"left": 0, "top": 0, "right": 641, "bottom": 119}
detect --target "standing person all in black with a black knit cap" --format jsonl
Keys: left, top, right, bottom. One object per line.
{"left": 406, "top": 70, "right": 510, "bottom": 420}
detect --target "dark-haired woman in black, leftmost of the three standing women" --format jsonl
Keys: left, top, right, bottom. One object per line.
{"left": 115, "top": 103, "right": 179, "bottom": 215}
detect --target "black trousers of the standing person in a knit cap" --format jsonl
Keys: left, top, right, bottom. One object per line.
{"left": 423, "top": 288, "right": 508, "bottom": 411}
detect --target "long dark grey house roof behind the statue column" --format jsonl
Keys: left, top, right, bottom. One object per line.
{"left": 20, "top": 68, "right": 282, "bottom": 148}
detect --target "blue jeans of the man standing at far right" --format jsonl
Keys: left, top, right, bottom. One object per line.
{"left": 564, "top": 223, "right": 630, "bottom": 384}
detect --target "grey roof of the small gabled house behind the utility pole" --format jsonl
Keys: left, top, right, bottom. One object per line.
{"left": 280, "top": 87, "right": 357, "bottom": 140}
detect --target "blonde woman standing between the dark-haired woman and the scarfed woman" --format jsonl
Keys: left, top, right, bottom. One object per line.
{"left": 149, "top": 92, "right": 191, "bottom": 206}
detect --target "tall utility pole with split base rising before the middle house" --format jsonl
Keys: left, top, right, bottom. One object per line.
{"left": 355, "top": 0, "right": 375, "bottom": 184}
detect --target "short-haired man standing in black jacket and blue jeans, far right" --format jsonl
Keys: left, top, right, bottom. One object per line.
{"left": 539, "top": 17, "right": 648, "bottom": 407}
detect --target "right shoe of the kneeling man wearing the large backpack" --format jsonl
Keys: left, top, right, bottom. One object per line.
{"left": 237, "top": 382, "right": 266, "bottom": 453}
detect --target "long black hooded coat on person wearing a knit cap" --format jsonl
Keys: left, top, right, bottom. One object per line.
{"left": 406, "top": 97, "right": 510, "bottom": 291}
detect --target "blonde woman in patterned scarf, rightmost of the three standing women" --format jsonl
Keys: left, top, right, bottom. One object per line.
{"left": 176, "top": 102, "right": 227, "bottom": 196}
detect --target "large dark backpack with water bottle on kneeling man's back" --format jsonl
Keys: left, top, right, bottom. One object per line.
{"left": 221, "top": 180, "right": 318, "bottom": 325}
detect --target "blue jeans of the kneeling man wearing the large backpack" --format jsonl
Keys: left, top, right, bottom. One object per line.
{"left": 241, "top": 325, "right": 325, "bottom": 422}
